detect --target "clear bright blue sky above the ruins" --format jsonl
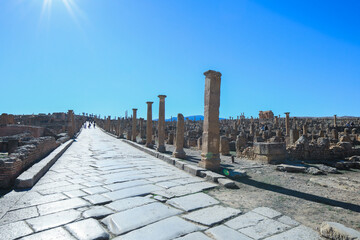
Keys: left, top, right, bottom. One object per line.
{"left": 0, "top": 0, "right": 360, "bottom": 118}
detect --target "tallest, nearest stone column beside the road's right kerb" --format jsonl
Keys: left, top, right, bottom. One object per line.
{"left": 199, "top": 70, "right": 221, "bottom": 170}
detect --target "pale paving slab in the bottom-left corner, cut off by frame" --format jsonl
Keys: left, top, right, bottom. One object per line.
{"left": 0, "top": 221, "right": 33, "bottom": 240}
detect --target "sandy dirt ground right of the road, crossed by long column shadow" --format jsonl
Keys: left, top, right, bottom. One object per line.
{"left": 167, "top": 145, "right": 360, "bottom": 231}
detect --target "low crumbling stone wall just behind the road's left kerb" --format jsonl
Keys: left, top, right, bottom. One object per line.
{"left": 0, "top": 137, "right": 59, "bottom": 188}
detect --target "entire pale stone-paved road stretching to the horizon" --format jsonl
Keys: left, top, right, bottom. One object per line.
{"left": 0, "top": 129, "right": 319, "bottom": 240}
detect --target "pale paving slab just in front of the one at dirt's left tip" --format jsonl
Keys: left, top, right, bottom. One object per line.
{"left": 183, "top": 205, "right": 241, "bottom": 226}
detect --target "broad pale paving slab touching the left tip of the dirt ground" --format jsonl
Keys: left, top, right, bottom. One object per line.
{"left": 167, "top": 193, "right": 219, "bottom": 211}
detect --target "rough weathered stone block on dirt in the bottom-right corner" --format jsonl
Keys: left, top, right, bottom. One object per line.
{"left": 320, "top": 222, "right": 360, "bottom": 240}
